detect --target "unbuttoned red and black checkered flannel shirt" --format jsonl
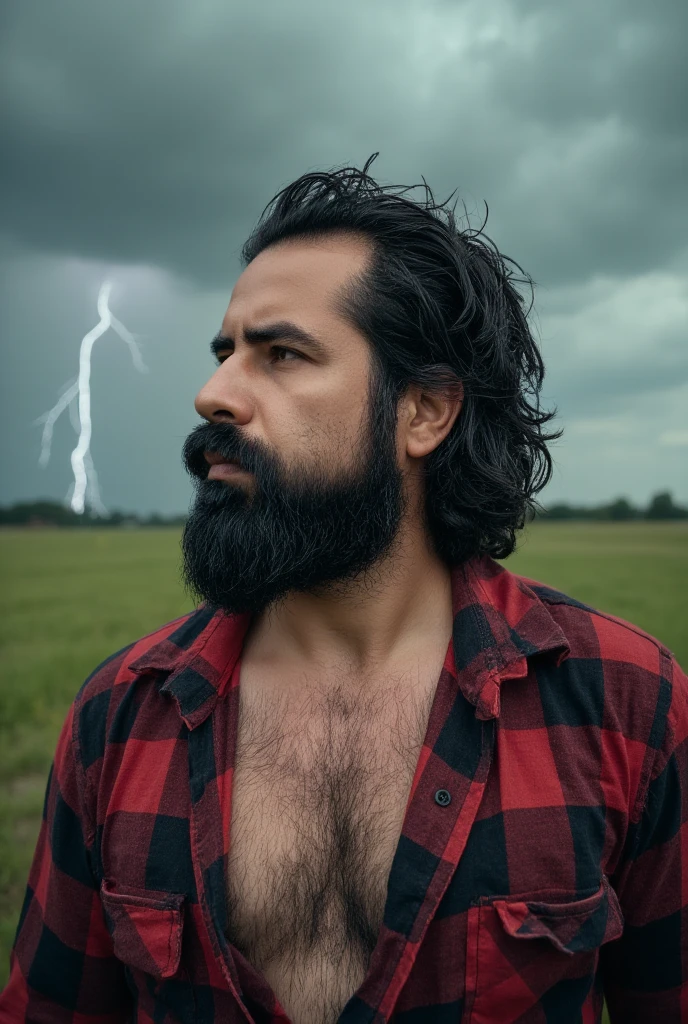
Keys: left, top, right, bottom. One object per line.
{"left": 0, "top": 558, "right": 688, "bottom": 1024}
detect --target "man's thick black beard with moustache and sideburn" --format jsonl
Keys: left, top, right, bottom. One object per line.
{"left": 182, "top": 370, "right": 406, "bottom": 614}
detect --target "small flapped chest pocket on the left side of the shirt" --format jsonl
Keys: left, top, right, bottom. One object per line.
{"left": 100, "top": 881, "right": 185, "bottom": 978}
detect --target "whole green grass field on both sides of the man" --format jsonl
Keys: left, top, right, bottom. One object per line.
{"left": 0, "top": 522, "right": 688, "bottom": 1011}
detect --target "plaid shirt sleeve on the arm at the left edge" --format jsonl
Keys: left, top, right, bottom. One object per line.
{"left": 0, "top": 706, "right": 132, "bottom": 1024}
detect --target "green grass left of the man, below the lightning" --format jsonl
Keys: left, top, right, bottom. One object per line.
{"left": 0, "top": 529, "right": 192, "bottom": 974}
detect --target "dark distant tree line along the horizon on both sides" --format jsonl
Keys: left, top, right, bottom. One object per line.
{"left": 0, "top": 490, "right": 688, "bottom": 528}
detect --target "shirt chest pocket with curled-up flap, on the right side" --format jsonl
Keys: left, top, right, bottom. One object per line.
{"left": 463, "top": 877, "right": 624, "bottom": 1024}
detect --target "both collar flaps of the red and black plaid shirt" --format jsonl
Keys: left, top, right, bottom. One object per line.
{"left": 128, "top": 555, "right": 570, "bottom": 729}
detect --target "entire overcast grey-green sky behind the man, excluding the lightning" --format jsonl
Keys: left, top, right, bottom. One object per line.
{"left": 0, "top": 0, "right": 688, "bottom": 513}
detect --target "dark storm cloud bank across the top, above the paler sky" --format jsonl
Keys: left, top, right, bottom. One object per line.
{"left": 0, "top": 0, "right": 688, "bottom": 285}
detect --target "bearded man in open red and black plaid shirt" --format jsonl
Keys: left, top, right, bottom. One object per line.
{"left": 0, "top": 158, "right": 688, "bottom": 1024}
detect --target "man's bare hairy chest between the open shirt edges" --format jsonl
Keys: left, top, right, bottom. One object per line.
{"left": 226, "top": 665, "right": 441, "bottom": 1022}
